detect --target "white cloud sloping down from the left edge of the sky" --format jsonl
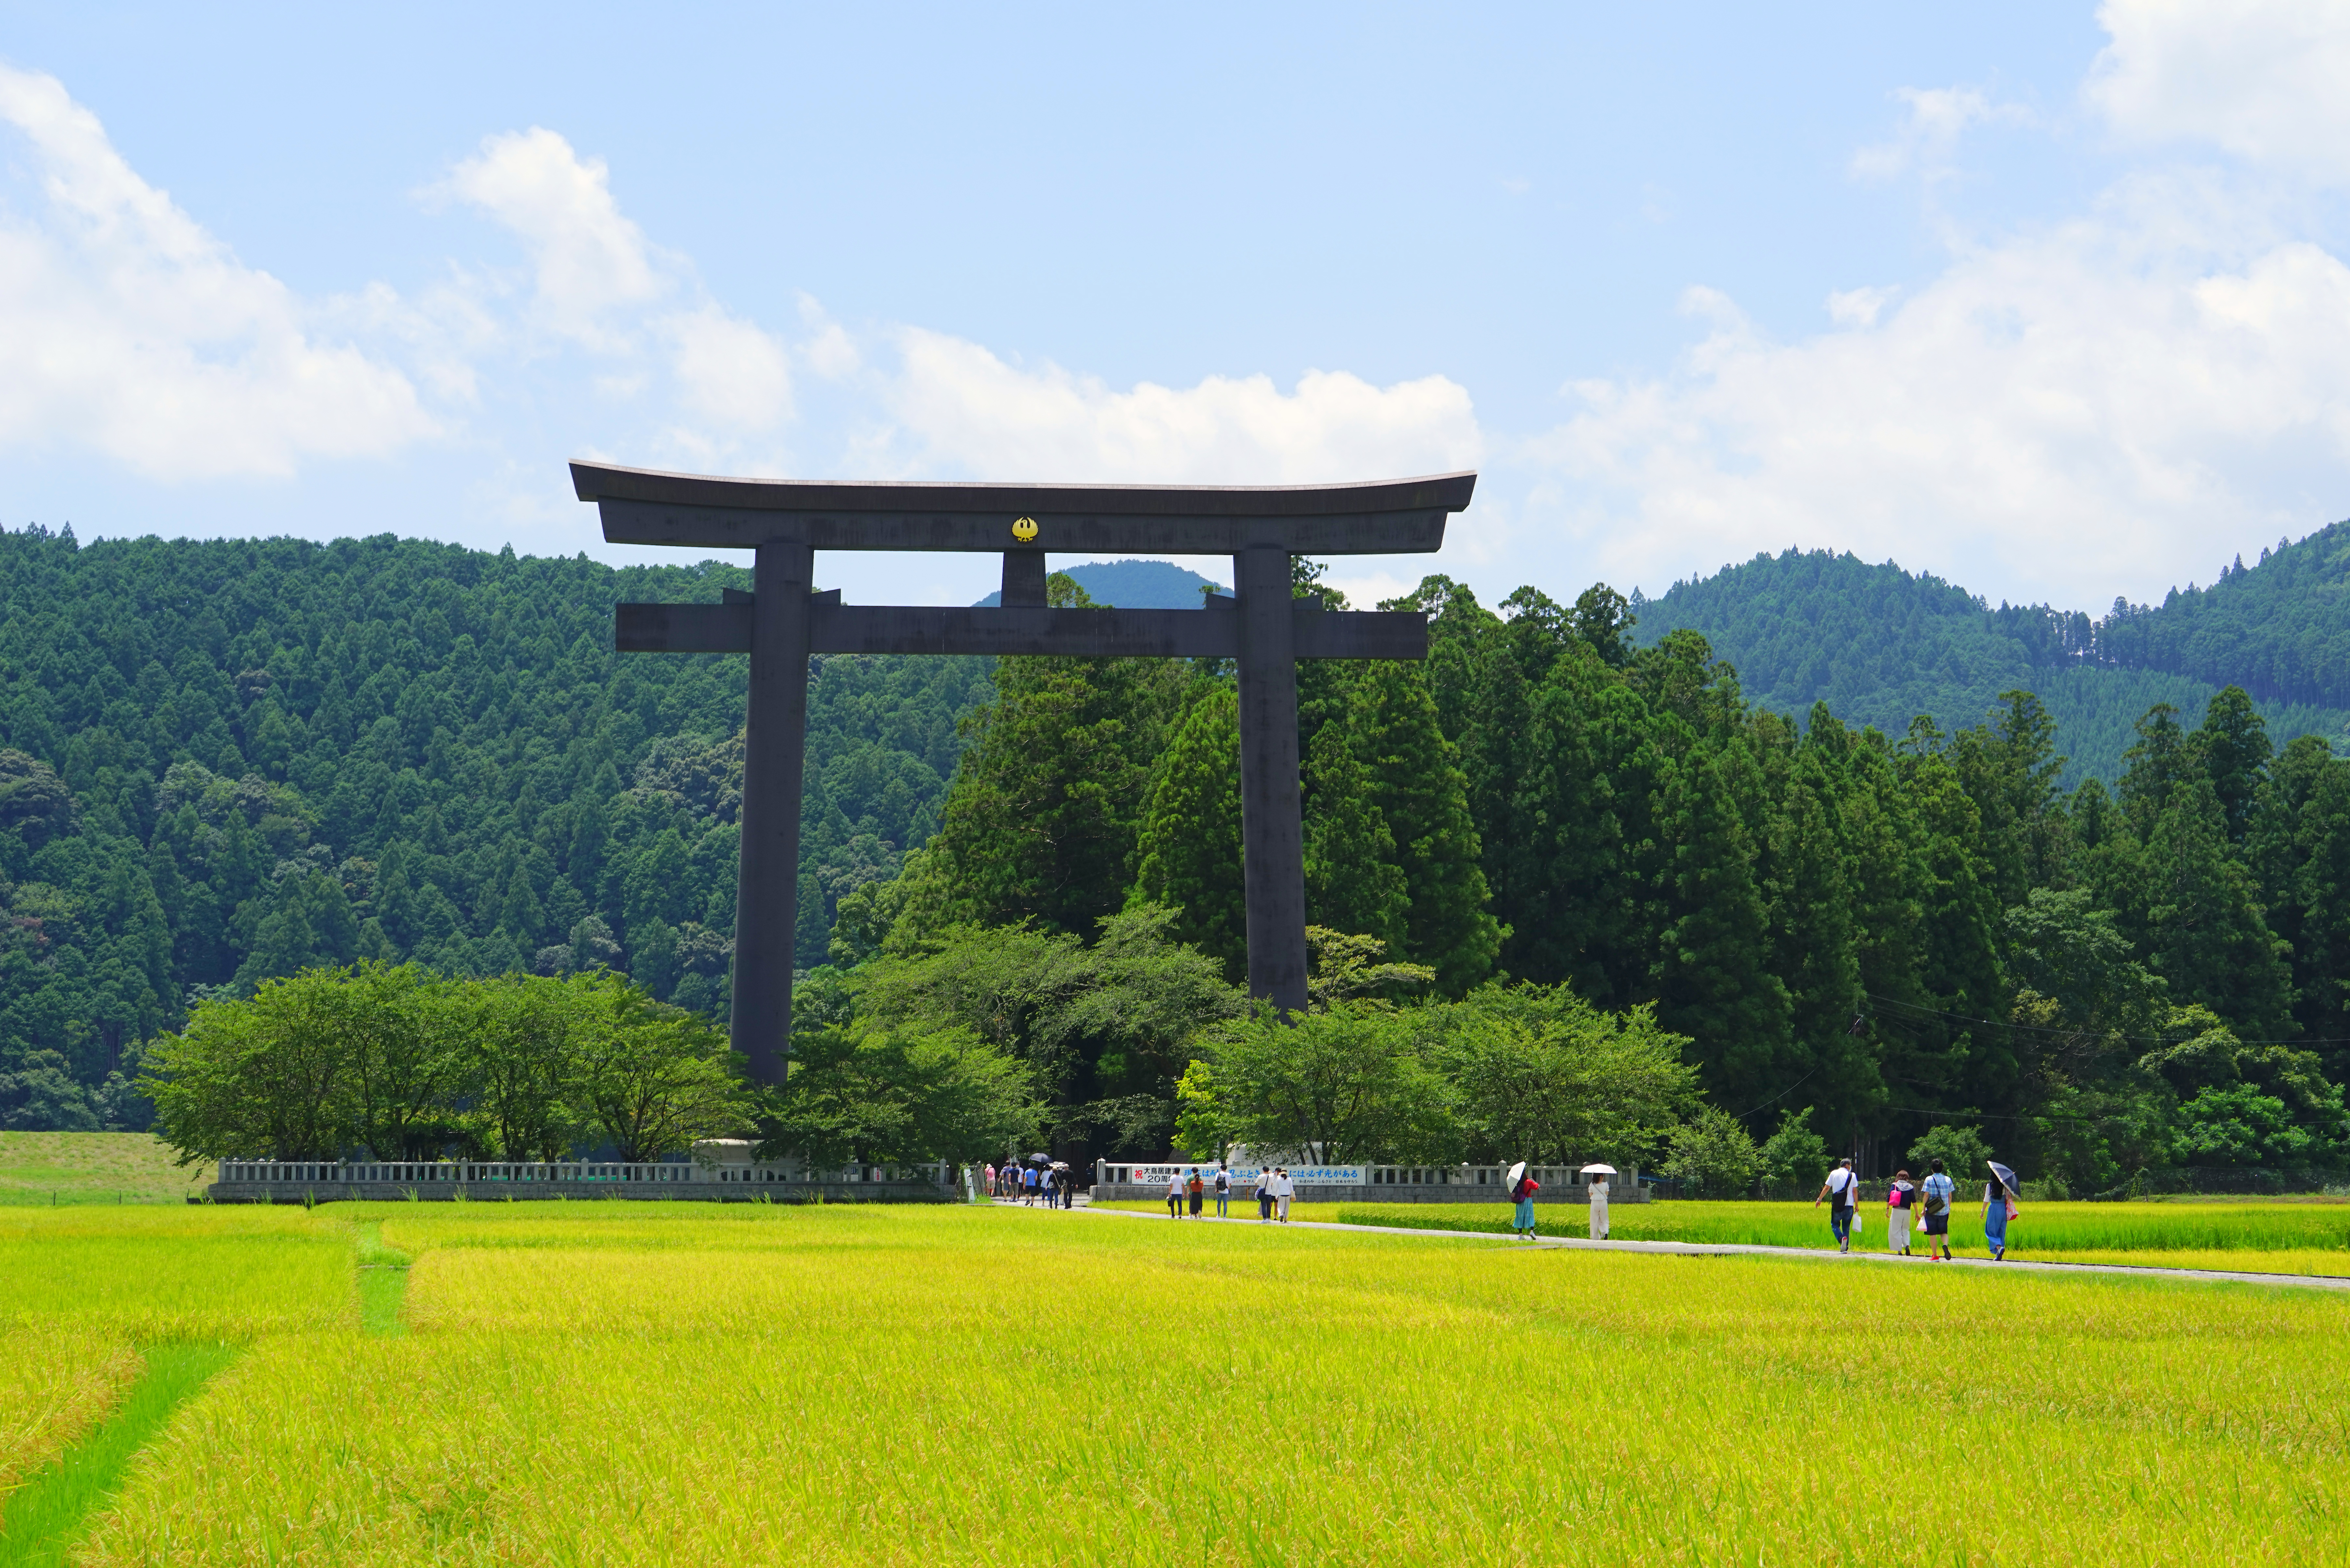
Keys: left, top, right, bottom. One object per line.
{"left": 0, "top": 66, "right": 435, "bottom": 479}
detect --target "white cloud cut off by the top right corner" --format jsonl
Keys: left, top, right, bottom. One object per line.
{"left": 2087, "top": 0, "right": 2350, "bottom": 179}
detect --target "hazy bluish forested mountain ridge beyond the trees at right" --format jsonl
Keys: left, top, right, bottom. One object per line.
{"left": 1633, "top": 524, "right": 2350, "bottom": 783}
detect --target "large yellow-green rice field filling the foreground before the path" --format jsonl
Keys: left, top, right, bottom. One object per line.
{"left": 0, "top": 1204, "right": 2350, "bottom": 1568}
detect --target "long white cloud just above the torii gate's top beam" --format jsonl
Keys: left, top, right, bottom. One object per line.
{"left": 886, "top": 329, "right": 1483, "bottom": 484}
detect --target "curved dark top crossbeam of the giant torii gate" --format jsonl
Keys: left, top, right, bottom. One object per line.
{"left": 571, "top": 463, "right": 1476, "bottom": 555}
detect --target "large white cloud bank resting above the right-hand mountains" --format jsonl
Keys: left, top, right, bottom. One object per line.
{"left": 1535, "top": 179, "right": 2350, "bottom": 609}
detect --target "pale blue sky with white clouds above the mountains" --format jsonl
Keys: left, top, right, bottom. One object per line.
{"left": 0, "top": 0, "right": 2350, "bottom": 609}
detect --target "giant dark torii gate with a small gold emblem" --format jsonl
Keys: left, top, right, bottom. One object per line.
{"left": 571, "top": 463, "right": 1476, "bottom": 1084}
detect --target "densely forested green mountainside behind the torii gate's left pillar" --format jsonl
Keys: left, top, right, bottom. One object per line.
{"left": 0, "top": 529, "right": 992, "bottom": 1126}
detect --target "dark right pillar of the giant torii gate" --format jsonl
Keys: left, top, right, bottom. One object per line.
{"left": 1232, "top": 548, "right": 1307, "bottom": 1013}
